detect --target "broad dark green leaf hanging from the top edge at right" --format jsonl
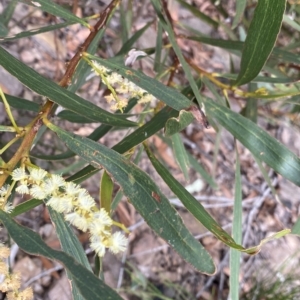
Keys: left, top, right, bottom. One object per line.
{"left": 234, "top": 0, "right": 286, "bottom": 86}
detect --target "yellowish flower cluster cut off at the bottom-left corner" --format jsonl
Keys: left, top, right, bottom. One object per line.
{"left": 0, "top": 244, "right": 33, "bottom": 300}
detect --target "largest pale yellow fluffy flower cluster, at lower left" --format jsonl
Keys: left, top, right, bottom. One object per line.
{"left": 12, "top": 168, "right": 127, "bottom": 257}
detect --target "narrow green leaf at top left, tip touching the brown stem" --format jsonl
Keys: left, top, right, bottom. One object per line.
{"left": 20, "top": 0, "right": 90, "bottom": 28}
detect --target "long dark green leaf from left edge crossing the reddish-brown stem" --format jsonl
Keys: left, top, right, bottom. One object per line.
{"left": 0, "top": 47, "right": 136, "bottom": 127}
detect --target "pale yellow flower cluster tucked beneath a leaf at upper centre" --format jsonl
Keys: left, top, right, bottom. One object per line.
{"left": 91, "top": 61, "right": 154, "bottom": 111}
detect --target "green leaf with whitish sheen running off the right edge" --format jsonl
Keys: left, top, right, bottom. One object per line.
{"left": 205, "top": 99, "right": 300, "bottom": 186}
